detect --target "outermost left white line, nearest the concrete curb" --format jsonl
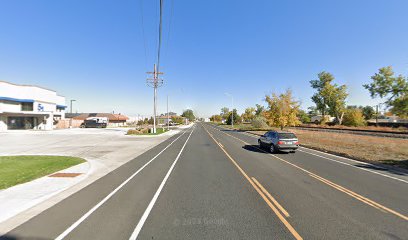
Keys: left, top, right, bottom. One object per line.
{"left": 55, "top": 132, "right": 186, "bottom": 240}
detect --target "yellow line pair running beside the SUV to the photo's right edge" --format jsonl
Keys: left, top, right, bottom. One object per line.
{"left": 207, "top": 124, "right": 408, "bottom": 221}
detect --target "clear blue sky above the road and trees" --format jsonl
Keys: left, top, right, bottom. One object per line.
{"left": 0, "top": 0, "right": 408, "bottom": 117}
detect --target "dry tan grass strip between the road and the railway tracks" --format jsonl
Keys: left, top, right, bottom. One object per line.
{"left": 249, "top": 129, "right": 408, "bottom": 168}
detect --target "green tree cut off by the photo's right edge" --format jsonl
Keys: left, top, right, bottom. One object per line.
{"left": 363, "top": 66, "right": 408, "bottom": 117}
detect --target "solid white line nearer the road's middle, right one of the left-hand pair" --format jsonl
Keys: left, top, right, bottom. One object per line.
{"left": 129, "top": 124, "right": 194, "bottom": 240}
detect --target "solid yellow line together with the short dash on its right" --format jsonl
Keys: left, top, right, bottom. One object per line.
{"left": 203, "top": 126, "right": 303, "bottom": 240}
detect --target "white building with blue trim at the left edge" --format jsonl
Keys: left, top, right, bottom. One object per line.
{"left": 0, "top": 81, "right": 66, "bottom": 131}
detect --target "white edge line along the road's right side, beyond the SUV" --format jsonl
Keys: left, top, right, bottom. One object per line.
{"left": 207, "top": 124, "right": 408, "bottom": 183}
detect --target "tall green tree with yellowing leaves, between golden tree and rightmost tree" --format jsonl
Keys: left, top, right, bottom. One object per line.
{"left": 310, "top": 71, "right": 348, "bottom": 124}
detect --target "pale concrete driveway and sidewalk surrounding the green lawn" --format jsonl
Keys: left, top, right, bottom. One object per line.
{"left": 0, "top": 126, "right": 188, "bottom": 235}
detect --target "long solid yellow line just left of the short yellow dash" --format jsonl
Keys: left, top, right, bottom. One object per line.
{"left": 202, "top": 126, "right": 303, "bottom": 240}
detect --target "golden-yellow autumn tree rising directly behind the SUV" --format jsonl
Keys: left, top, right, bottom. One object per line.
{"left": 265, "top": 90, "right": 300, "bottom": 129}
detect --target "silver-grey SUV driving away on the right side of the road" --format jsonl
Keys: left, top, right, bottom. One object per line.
{"left": 258, "top": 131, "right": 299, "bottom": 153}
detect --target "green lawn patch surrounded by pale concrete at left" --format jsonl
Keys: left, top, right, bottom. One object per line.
{"left": 0, "top": 156, "right": 85, "bottom": 189}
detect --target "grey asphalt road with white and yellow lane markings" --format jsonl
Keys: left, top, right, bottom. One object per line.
{"left": 0, "top": 123, "right": 408, "bottom": 240}
